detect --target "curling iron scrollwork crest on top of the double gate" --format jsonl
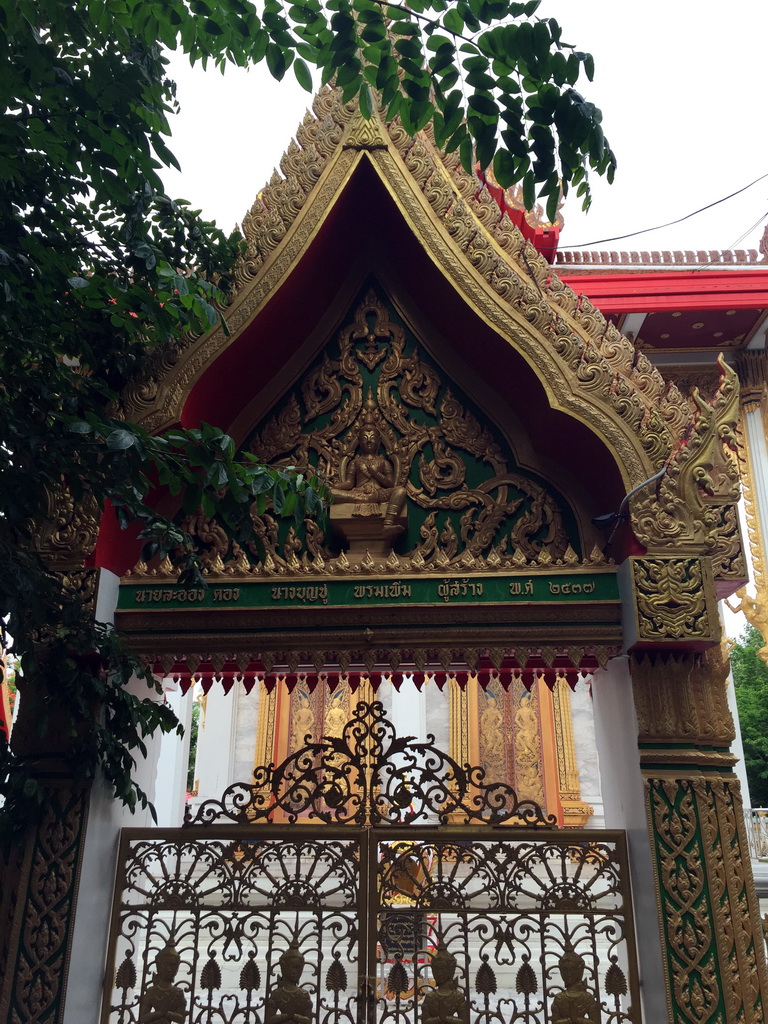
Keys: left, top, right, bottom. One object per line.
{"left": 185, "top": 701, "right": 557, "bottom": 827}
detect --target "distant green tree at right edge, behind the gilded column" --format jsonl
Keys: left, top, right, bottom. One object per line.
{"left": 731, "top": 626, "right": 768, "bottom": 807}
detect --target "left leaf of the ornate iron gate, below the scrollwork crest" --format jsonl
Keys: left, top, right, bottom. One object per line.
{"left": 101, "top": 826, "right": 369, "bottom": 1024}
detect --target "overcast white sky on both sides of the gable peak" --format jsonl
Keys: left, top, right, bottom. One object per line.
{"left": 162, "top": 0, "right": 768, "bottom": 250}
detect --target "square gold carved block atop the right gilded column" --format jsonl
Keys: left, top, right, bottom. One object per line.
{"left": 620, "top": 555, "right": 721, "bottom": 650}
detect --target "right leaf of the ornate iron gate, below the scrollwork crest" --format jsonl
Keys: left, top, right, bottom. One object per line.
{"left": 375, "top": 828, "right": 640, "bottom": 1024}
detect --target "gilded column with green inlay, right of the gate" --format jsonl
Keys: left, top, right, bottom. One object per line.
{"left": 632, "top": 647, "right": 768, "bottom": 1024}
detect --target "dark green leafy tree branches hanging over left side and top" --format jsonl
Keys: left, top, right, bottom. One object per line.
{"left": 0, "top": 0, "right": 614, "bottom": 827}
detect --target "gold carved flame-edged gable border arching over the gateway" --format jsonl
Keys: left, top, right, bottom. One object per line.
{"left": 124, "top": 89, "right": 740, "bottom": 578}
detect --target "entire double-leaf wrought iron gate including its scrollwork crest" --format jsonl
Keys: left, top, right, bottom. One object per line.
{"left": 102, "top": 705, "right": 640, "bottom": 1024}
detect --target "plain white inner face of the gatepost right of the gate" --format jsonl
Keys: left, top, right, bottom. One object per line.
{"left": 592, "top": 656, "right": 669, "bottom": 1024}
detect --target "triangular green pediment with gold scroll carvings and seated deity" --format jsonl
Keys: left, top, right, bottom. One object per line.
{"left": 246, "top": 288, "right": 579, "bottom": 571}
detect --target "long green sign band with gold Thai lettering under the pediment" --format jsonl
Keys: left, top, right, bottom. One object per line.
{"left": 118, "top": 571, "right": 618, "bottom": 611}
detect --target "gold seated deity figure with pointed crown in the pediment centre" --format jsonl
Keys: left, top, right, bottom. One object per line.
{"left": 331, "top": 394, "right": 406, "bottom": 525}
